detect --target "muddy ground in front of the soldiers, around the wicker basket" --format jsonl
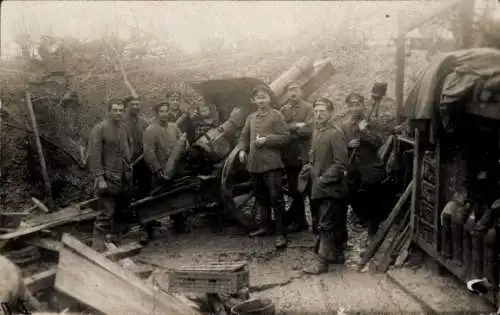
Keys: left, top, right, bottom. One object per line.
{"left": 131, "top": 211, "right": 492, "bottom": 314}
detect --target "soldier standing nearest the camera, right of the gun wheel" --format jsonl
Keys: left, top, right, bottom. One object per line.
{"left": 303, "top": 98, "right": 349, "bottom": 274}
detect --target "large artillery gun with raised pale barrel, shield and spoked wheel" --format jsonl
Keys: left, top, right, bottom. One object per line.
{"left": 131, "top": 57, "right": 334, "bottom": 229}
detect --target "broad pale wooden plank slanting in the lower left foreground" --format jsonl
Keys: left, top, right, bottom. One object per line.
{"left": 55, "top": 234, "right": 199, "bottom": 315}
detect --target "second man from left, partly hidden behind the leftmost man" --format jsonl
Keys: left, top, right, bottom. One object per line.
{"left": 124, "top": 96, "right": 151, "bottom": 199}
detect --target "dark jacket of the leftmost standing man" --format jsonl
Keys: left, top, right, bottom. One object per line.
{"left": 88, "top": 120, "right": 132, "bottom": 184}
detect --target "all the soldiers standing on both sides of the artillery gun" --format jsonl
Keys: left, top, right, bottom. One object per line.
{"left": 88, "top": 82, "right": 386, "bottom": 274}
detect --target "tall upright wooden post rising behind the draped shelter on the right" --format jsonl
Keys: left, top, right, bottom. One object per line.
{"left": 395, "top": 13, "right": 406, "bottom": 124}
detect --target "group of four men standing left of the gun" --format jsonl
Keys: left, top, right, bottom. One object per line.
{"left": 88, "top": 92, "right": 193, "bottom": 249}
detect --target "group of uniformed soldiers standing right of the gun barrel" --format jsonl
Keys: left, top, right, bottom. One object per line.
{"left": 238, "top": 82, "right": 387, "bottom": 274}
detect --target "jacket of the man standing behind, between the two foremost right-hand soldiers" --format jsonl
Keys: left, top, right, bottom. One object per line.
{"left": 281, "top": 100, "right": 313, "bottom": 166}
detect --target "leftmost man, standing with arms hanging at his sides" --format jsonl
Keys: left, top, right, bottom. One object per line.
{"left": 88, "top": 99, "right": 132, "bottom": 250}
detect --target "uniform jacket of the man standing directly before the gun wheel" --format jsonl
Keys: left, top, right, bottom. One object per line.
{"left": 238, "top": 108, "right": 289, "bottom": 173}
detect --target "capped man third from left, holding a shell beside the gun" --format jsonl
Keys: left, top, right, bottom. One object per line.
{"left": 143, "top": 103, "right": 188, "bottom": 233}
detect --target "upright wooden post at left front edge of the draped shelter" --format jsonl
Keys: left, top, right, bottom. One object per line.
{"left": 410, "top": 128, "right": 423, "bottom": 240}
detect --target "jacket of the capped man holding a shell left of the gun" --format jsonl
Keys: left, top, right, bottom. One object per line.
{"left": 143, "top": 121, "right": 181, "bottom": 174}
